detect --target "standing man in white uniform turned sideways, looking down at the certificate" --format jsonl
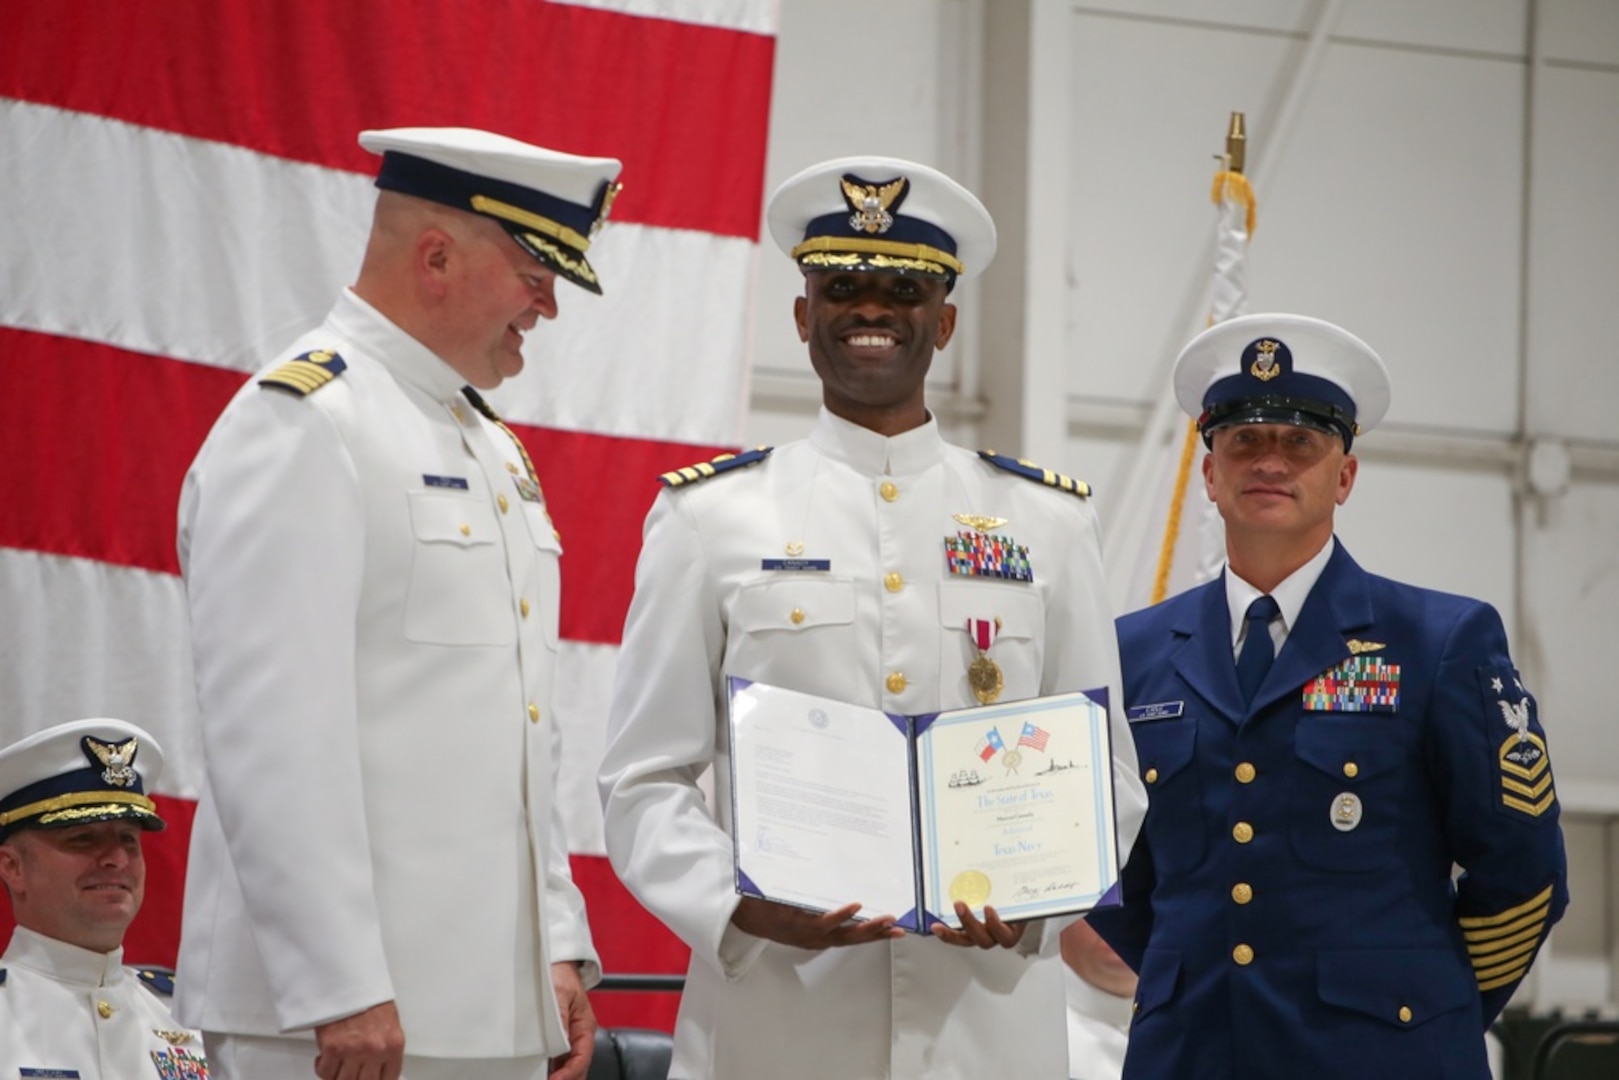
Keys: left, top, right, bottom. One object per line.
{"left": 178, "top": 128, "right": 618, "bottom": 1080}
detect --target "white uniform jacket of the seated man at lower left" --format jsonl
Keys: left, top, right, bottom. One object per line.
{"left": 0, "top": 926, "right": 207, "bottom": 1080}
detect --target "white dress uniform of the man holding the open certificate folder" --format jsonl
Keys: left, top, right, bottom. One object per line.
{"left": 602, "top": 410, "right": 1146, "bottom": 1080}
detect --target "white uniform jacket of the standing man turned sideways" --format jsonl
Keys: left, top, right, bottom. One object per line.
{"left": 178, "top": 291, "right": 599, "bottom": 1057}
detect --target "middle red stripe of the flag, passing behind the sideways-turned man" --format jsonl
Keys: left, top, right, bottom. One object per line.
{"left": 0, "top": 327, "right": 722, "bottom": 644}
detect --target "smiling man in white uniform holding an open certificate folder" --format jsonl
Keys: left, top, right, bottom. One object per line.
{"left": 601, "top": 157, "right": 1145, "bottom": 1080}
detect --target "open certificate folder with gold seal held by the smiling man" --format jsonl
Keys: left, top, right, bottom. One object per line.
{"left": 729, "top": 677, "right": 1119, "bottom": 933}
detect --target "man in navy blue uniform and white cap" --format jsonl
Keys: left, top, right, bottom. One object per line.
{"left": 1090, "top": 314, "right": 1567, "bottom": 1080}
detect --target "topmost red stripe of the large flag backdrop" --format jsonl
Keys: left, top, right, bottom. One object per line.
{"left": 0, "top": 0, "right": 776, "bottom": 240}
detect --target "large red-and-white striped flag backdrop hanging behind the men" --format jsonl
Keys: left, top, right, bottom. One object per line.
{"left": 0, "top": 0, "right": 776, "bottom": 1027}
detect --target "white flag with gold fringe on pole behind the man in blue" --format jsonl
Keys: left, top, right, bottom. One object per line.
{"left": 1107, "top": 112, "right": 1256, "bottom": 612}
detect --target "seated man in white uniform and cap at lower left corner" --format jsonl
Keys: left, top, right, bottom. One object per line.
{"left": 0, "top": 721, "right": 207, "bottom": 1080}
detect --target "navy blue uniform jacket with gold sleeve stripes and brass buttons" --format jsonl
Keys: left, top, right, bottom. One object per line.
{"left": 1091, "top": 546, "right": 1567, "bottom": 1080}
